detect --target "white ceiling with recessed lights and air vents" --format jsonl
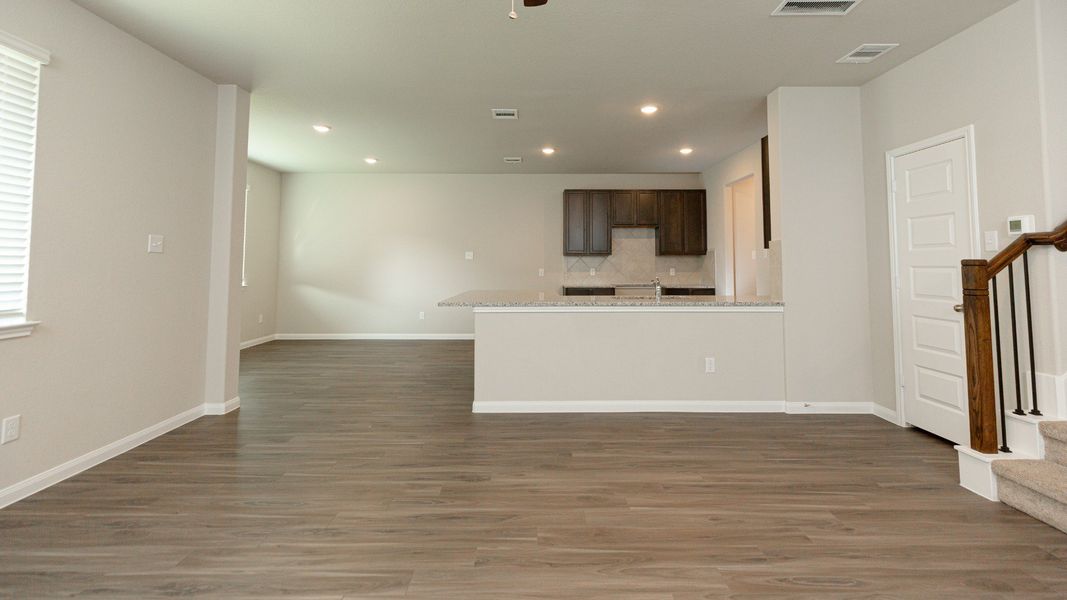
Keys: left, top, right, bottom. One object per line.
{"left": 76, "top": 0, "right": 1015, "bottom": 173}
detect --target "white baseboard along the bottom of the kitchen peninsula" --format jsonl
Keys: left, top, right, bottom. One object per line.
{"left": 473, "top": 400, "right": 785, "bottom": 413}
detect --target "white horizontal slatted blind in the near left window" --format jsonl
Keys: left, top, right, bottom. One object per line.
{"left": 0, "top": 37, "right": 42, "bottom": 318}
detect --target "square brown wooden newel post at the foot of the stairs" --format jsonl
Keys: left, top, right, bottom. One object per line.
{"left": 964, "top": 260, "right": 997, "bottom": 454}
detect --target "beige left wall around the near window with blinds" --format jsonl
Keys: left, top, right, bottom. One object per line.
{"left": 0, "top": 0, "right": 230, "bottom": 490}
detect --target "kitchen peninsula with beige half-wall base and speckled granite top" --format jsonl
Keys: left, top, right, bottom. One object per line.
{"left": 439, "top": 289, "right": 785, "bottom": 412}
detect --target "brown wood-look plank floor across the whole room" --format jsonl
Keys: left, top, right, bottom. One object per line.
{"left": 0, "top": 342, "right": 1067, "bottom": 600}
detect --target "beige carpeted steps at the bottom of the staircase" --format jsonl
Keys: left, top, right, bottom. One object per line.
{"left": 992, "top": 421, "right": 1067, "bottom": 532}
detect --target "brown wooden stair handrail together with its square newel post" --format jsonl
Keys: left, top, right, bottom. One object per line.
{"left": 962, "top": 216, "right": 1067, "bottom": 454}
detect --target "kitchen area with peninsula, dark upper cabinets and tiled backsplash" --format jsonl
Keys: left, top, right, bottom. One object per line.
{"left": 439, "top": 189, "right": 785, "bottom": 413}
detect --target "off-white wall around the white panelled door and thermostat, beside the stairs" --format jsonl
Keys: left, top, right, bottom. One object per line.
{"left": 861, "top": 0, "right": 1067, "bottom": 407}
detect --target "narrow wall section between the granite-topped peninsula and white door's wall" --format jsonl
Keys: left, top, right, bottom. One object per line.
{"left": 767, "top": 88, "right": 872, "bottom": 402}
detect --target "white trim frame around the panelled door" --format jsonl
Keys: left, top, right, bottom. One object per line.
{"left": 886, "top": 124, "right": 982, "bottom": 427}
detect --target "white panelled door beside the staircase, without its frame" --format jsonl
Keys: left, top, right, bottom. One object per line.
{"left": 892, "top": 139, "right": 977, "bottom": 444}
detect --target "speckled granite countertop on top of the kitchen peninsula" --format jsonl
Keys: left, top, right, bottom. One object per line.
{"left": 437, "top": 289, "right": 784, "bottom": 309}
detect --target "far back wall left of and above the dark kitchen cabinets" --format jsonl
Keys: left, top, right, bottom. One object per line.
{"left": 277, "top": 174, "right": 701, "bottom": 334}
